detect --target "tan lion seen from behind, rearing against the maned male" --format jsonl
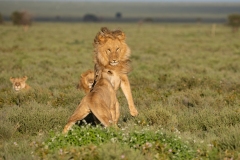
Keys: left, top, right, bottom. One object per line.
{"left": 63, "top": 69, "right": 120, "bottom": 133}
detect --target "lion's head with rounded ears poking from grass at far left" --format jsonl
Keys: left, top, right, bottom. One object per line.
{"left": 9, "top": 76, "right": 31, "bottom": 92}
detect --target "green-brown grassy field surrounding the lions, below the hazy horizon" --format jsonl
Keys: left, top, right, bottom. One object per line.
{"left": 0, "top": 23, "right": 240, "bottom": 160}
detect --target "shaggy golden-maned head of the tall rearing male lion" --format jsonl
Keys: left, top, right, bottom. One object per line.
{"left": 94, "top": 27, "right": 130, "bottom": 66}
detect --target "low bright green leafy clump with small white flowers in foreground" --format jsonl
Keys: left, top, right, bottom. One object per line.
{"left": 43, "top": 125, "right": 196, "bottom": 159}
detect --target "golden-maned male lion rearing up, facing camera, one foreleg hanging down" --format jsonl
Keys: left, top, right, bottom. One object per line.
{"left": 94, "top": 27, "right": 138, "bottom": 116}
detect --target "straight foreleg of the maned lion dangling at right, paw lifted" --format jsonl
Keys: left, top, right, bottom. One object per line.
{"left": 121, "top": 74, "right": 138, "bottom": 116}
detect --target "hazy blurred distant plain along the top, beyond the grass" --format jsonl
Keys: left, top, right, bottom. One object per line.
{"left": 0, "top": 0, "right": 240, "bottom": 23}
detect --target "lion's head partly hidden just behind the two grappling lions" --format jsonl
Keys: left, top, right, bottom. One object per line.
{"left": 77, "top": 70, "right": 94, "bottom": 94}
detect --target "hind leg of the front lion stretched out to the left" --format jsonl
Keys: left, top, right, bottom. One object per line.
{"left": 63, "top": 101, "right": 91, "bottom": 133}
